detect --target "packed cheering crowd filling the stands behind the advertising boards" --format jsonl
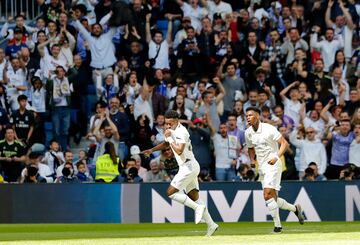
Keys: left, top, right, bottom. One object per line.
{"left": 0, "top": 0, "right": 360, "bottom": 183}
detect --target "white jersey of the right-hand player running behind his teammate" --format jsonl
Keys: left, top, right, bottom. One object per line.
{"left": 245, "top": 122, "right": 281, "bottom": 168}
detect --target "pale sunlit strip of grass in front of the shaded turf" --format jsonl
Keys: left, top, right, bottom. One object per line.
{"left": 0, "top": 232, "right": 360, "bottom": 245}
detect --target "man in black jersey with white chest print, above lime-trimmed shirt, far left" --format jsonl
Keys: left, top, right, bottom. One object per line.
{"left": 10, "top": 94, "right": 34, "bottom": 145}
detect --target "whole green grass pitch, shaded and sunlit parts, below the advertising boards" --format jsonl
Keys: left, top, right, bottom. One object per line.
{"left": 0, "top": 222, "right": 360, "bottom": 245}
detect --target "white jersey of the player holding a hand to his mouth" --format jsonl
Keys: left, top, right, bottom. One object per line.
{"left": 171, "top": 123, "right": 196, "bottom": 166}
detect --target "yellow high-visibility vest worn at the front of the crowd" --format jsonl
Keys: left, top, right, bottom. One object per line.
{"left": 95, "top": 154, "right": 119, "bottom": 183}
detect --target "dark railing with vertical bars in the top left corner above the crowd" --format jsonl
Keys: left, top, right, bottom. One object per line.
{"left": 0, "top": 0, "right": 40, "bottom": 23}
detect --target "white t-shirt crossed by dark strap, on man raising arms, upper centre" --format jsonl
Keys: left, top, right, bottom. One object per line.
{"left": 149, "top": 40, "right": 170, "bottom": 69}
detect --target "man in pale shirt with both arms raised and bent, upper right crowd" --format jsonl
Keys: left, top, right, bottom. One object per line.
{"left": 310, "top": 26, "right": 344, "bottom": 72}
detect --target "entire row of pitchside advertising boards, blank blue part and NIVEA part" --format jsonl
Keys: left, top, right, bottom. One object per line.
{"left": 0, "top": 181, "right": 360, "bottom": 223}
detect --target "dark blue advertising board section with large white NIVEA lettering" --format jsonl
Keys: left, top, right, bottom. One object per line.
{"left": 140, "top": 181, "right": 360, "bottom": 223}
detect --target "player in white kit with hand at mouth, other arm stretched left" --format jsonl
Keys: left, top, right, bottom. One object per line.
{"left": 142, "top": 110, "right": 219, "bottom": 236}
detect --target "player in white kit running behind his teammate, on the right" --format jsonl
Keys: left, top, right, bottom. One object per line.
{"left": 245, "top": 107, "right": 304, "bottom": 233}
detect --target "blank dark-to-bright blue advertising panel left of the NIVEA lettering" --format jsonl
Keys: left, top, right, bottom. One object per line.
{"left": 0, "top": 184, "right": 121, "bottom": 223}
